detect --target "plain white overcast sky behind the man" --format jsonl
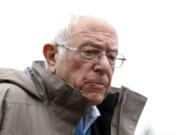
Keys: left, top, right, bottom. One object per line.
{"left": 0, "top": 0, "right": 180, "bottom": 135}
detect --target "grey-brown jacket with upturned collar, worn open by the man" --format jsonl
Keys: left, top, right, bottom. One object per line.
{"left": 0, "top": 63, "right": 146, "bottom": 135}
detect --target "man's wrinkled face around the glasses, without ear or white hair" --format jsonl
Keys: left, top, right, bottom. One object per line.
{"left": 46, "top": 18, "right": 118, "bottom": 105}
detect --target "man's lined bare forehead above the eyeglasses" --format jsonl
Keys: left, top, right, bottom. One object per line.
{"left": 68, "top": 17, "right": 118, "bottom": 46}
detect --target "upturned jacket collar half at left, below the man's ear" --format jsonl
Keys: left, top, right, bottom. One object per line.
{"left": 29, "top": 61, "right": 88, "bottom": 119}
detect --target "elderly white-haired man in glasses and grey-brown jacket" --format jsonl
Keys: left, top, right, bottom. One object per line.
{"left": 0, "top": 16, "right": 146, "bottom": 135}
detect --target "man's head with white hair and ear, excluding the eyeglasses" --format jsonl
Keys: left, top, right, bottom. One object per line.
{"left": 43, "top": 16, "right": 118, "bottom": 105}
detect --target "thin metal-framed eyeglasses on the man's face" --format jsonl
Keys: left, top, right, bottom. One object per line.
{"left": 57, "top": 44, "right": 126, "bottom": 68}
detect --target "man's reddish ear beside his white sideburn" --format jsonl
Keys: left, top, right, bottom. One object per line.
{"left": 43, "top": 44, "right": 57, "bottom": 72}
